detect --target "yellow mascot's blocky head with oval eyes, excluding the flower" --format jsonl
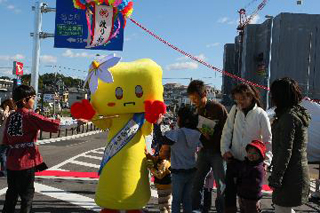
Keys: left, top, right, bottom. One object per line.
{"left": 91, "top": 59, "right": 163, "bottom": 115}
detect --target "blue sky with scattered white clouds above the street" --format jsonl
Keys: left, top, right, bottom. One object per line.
{"left": 0, "top": 0, "right": 320, "bottom": 89}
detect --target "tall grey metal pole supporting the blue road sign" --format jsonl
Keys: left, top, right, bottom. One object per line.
{"left": 31, "top": 1, "right": 43, "bottom": 109}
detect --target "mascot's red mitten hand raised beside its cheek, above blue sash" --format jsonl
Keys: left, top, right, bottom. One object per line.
{"left": 144, "top": 100, "right": 166, "bottom": 124}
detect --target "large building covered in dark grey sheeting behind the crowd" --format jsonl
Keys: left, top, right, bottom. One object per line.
{"left": 222, "top": 13, "right": 320, "bottom": 106}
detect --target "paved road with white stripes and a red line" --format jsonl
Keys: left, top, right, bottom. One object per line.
{"left": 0, "top": 133, "right": 320, "bottom": 213}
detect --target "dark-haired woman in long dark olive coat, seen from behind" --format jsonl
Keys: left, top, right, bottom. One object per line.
{"left": 269, "top": 78, "right": 310, "bottom": 213}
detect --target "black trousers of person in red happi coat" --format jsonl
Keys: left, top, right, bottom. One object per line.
{"left": 2, "top": 168, "right": 35, "bottom": 213}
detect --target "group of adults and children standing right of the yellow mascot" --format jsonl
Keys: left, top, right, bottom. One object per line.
{"left": 147, "top": 78, "right": 311, "bottom": 213}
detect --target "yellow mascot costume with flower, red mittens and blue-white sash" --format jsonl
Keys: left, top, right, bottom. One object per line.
{"left": 71, "top": 56, "right": 165, "bottom": 213}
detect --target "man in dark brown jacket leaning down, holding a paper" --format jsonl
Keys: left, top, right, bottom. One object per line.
{"left": 187, "top": 80, "right": 228, "bottom": 213}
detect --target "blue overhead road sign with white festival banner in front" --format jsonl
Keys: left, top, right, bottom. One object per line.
{"left": 54, "top": 0, "right": 124, "bottom": 51}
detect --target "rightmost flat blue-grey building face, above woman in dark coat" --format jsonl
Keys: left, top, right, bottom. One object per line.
{"left": 271, "top": 13, "right": 320, "bottom": 99}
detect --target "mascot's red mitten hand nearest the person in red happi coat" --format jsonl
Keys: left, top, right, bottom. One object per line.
{"left": 70, "top": 99, "right": 96, "bottom": 120}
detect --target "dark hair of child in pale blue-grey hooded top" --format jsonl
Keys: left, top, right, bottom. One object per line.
{"left": 178, "top": 106, "right": 198, "bottom": 129}
